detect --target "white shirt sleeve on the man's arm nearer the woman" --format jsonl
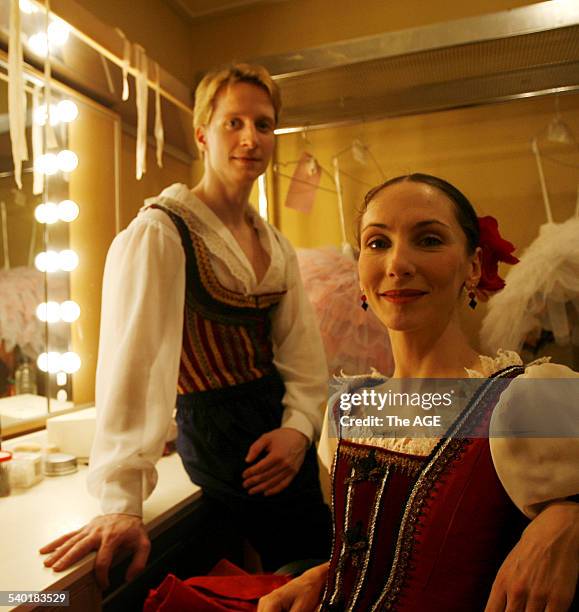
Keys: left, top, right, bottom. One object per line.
{"left": 272, "top": 237, "right": 328, "bottom": 442}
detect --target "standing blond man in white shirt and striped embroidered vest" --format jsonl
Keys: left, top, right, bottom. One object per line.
{"left": 41, "top": 64, "right": 330, "bottom": 585}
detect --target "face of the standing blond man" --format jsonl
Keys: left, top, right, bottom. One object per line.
{"left": 196, "top": 82, "right": 275, "bottom": 186}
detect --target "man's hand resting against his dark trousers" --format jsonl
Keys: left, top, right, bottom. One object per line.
{"left": 242, "top": 427, "right": 310, "bottom": 495}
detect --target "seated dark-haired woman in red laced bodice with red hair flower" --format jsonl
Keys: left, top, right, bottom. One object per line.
{"left": 258, "top": 174, "right": 579, "bottom": 612}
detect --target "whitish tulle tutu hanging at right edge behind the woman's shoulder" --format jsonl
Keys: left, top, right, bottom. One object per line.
{"left": 481, "top": 218, "right": 579, "bottom": 354}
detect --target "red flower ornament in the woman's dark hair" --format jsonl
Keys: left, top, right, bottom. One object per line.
{"left": 475, "top": 216, "right": 519, "bottom": 302}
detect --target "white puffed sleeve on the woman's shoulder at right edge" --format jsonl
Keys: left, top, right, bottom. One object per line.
{"left": 490, "top": 363, "right": 579, "bottom": 518}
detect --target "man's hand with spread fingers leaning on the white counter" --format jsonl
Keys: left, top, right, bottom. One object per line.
{"left": 39, "top": 514, "right": 151, "bottom": 589}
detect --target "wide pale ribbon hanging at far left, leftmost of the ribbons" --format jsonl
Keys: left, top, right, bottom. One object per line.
{"left": 8, "top": 0, "right": 28, "bottom": 189}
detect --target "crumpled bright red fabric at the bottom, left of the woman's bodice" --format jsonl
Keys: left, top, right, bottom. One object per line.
{"left": 143, "top": 560, "right": 291, "bottom": 612}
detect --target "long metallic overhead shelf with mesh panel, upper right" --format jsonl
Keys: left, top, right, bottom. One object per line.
{"left": 255, "top": 0, "right": 579, "bottom": 129}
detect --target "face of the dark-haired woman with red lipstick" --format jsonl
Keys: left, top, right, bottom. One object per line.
{"left": 358, "top": 181, "right": 480, "bottom": 332}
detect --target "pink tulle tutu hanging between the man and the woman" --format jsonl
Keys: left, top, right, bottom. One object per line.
{"left": 297, "top": 247, "right": 394, "bottom": 375}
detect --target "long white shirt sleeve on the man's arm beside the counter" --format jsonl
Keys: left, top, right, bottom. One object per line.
{"left": 88, "top": 211, "right": 185, "bottom": 516}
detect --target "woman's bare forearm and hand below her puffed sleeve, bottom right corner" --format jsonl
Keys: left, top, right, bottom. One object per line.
{"left": 485, "top": 501, "right": 579, "bottom": 612}
